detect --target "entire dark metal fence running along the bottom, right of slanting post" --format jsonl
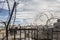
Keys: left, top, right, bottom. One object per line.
{"left": 3, "top": 27, "right": 60, "bottom": 40}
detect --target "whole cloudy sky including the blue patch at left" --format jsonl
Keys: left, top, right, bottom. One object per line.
{"left": 0, "top": 0, "right": 60, "bottom": 25}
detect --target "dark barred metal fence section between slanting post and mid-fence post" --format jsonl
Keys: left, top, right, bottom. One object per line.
{"left": 9, "top": 28, "right": 38, "bottom": 40}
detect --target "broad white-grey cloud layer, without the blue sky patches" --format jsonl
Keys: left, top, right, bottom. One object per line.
{"left": 0, "top": 0, "right": 60, "bottom": 24}
